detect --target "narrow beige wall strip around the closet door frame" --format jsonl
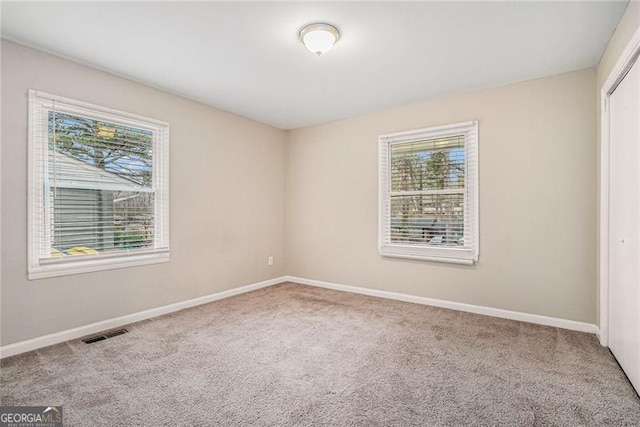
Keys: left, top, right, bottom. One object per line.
{"left": 596, "top": 0, "right": 640, "bottom": 324}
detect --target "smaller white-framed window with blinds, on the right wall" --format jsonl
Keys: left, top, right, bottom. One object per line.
{"left": 378, "top": 121, "right": 478, "bottom": 264}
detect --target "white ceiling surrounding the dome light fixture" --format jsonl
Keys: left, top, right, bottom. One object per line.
{"left": 2, "top": 1, "right": 626, "bottom": 129}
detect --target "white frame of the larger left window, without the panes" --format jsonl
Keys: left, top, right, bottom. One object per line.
{"left": 27, "top": 89, "right": 170, "bottom": 280}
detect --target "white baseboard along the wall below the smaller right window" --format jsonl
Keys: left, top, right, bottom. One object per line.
{"left": 285, "top": 276, "right": 600, "bottom": 335}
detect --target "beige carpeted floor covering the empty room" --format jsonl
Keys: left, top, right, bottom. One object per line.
{"left": 0, "top": 283, "right": 640, "bottom": 426}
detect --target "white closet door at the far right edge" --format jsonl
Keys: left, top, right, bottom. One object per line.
{"left": 609, "top": 56, "right": 640, "bottom": 391}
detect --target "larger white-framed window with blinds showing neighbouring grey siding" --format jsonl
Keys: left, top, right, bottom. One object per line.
{"left": 28, "top": 90, "right": 169, "bottom": 279}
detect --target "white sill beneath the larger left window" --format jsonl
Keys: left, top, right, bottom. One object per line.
{"left": 28, "top": 251, "right": 169, "bottom": 280}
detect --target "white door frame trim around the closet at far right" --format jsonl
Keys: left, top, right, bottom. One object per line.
{"left": 599, "top": 28, "right": 640, "bottom": 347}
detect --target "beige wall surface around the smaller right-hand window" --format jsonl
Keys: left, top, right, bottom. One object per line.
{"left": 286, "top": 69, "right": 596, "bottom": 323}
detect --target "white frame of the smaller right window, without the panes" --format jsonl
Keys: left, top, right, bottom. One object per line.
{"left": 378, "top": 121, "right": 480, "bottom": 264}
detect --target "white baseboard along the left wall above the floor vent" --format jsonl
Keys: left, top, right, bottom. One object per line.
{"left": 0, "top": 277, "right": 286, "bottom": 358}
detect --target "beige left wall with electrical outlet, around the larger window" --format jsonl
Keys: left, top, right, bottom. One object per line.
{"left": 1, "top": 41, "right": 285, "bottom": 345}
